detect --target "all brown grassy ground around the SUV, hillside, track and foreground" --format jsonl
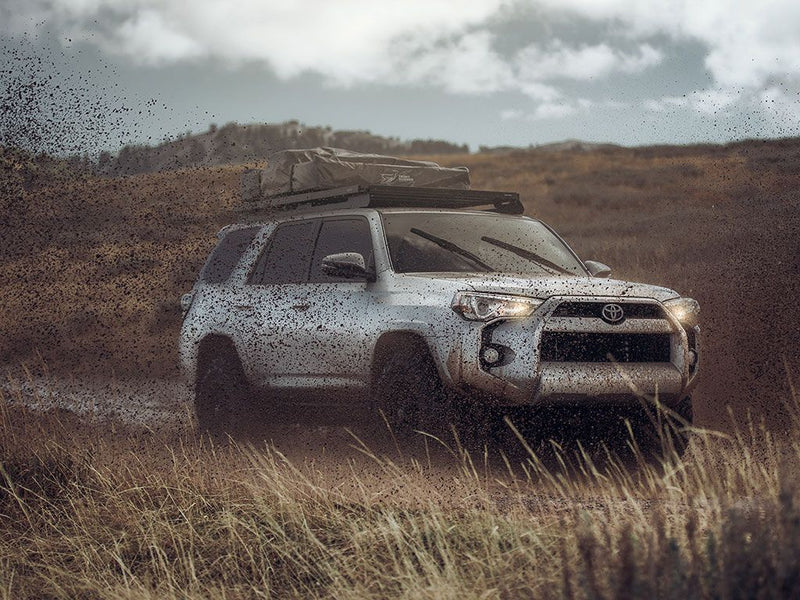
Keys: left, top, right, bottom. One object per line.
{"left": 0, "top": 140, "right": 800, "bottom": 600}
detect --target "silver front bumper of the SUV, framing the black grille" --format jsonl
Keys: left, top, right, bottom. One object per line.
{"left": 448, "top": 297, "right": 700, "bottom": 406}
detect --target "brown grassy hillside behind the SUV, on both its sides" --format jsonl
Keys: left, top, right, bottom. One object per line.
{"left": 0, "top": 140, "right": 800, "bottom": 432}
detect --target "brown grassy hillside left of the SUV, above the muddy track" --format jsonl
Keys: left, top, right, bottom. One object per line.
{"left": 0, "top": 168, "right": 244, "bottom": 375}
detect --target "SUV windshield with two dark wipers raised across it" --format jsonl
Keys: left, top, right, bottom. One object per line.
{"left": 383, "top": 212, "right": 586, "bottom": 276}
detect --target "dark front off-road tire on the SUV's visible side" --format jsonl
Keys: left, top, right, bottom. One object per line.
{"left": 372, "top": 348, "right": 447, "bottom": 434}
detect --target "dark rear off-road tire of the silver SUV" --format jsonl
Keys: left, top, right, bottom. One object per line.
{"left": 195, "top": 348, "right": 248, "bottom": 435}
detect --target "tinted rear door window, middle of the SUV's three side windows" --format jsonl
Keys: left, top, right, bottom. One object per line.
{"left": 248, "top": 221, "right": 319, "bottom": 285}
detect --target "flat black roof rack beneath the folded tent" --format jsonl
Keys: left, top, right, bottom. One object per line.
{"left": 238, "top": 185, "right": 524, "bottom": 215}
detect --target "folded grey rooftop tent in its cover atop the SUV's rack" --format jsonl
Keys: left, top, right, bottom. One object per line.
{"left": 242, "top": 147, "right": 469, "bottom": 201}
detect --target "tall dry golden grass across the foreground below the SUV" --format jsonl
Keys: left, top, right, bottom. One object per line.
{"left": 0, "top": 376, "right": 800, "bottom": 600}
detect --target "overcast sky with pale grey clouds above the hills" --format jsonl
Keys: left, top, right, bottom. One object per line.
{"left": 0, "top": 0, "right": 800, "bottom": 150}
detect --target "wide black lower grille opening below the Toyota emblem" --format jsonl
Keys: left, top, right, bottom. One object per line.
{"left": 541, "top": 331, "right": 670, "bottom": 363}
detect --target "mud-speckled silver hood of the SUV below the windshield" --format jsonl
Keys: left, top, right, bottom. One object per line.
{"left": 404, "top": 273, "right": 679, "bottom": 302}
